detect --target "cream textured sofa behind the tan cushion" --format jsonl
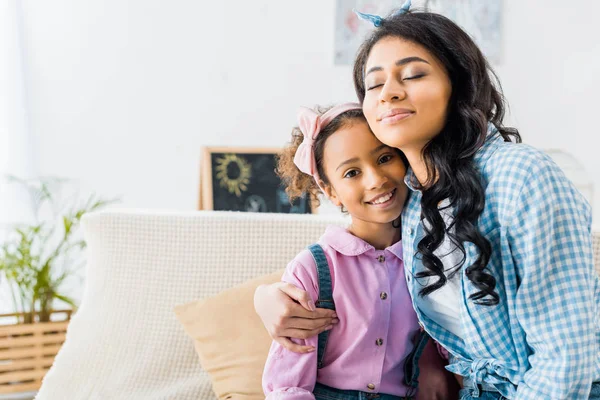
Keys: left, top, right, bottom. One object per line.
{"left": 36, "top": 210, "right": 600, "bottom": 400}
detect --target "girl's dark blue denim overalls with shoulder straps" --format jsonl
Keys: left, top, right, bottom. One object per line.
{"left": 308, "top": 244, "right": 429, "bottom": 400}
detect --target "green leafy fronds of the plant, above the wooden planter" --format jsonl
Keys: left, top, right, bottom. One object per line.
{"left": 0, "top": 178, "right": 112, "bottom": 323}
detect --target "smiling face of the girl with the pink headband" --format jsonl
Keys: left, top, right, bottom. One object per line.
{"left": 323, "top": 120, "right": 408, "bottom": 223}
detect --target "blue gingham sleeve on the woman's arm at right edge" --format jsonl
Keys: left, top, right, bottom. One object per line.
{"left": 508, "top": 158, "right": 598, "bottom": 400}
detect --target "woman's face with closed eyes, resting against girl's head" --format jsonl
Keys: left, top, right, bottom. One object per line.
{"left": 363, "top": 37, "right": 452, "bottom": 155}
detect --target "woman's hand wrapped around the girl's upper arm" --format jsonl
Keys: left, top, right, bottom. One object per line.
{"left": 254, "top": 282, "right": 339, "bottom": 353}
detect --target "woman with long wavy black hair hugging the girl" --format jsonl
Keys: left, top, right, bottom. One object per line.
{"left": 255, "top": 1, "right": 600, "bottom": 400}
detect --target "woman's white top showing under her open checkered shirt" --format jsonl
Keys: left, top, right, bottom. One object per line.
{"left": 416, "top": 200, "right": 464, "bottom": 338}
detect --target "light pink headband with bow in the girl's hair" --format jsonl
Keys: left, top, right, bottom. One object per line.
{"left": 294, "top": 103, "right": 362, "bottom": 194}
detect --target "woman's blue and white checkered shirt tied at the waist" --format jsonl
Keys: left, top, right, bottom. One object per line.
{"left": 402, "top": 127, "right": 600, "bottom": 400}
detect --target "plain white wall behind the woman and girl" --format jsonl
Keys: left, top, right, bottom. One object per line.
{"left": 16, "top": 0, "right": 600, "bottom": 221}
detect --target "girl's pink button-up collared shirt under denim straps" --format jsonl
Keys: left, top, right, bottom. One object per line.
{"left": 263, "top": 226, "right": 419, "bottom": 400}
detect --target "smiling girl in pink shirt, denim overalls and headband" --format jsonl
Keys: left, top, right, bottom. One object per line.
{"left": 263, "top": 103, "right": 454, "bottom": 400}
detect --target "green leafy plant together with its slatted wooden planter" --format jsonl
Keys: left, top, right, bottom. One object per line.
{"left": 0, "top": 178, "right": 112, "bottom": 395}
